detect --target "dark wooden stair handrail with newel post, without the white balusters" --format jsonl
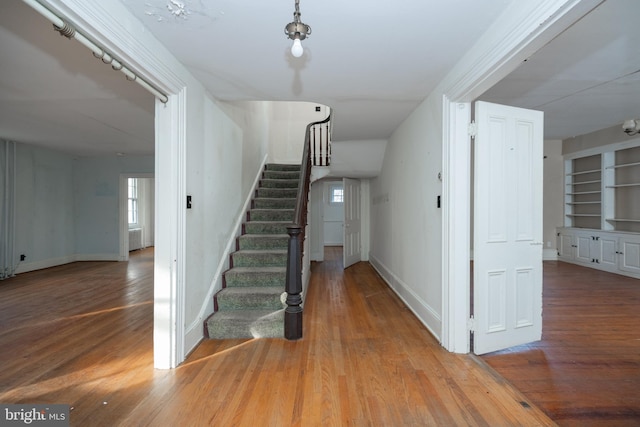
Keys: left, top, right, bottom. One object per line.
{"left": 284, "top": 114, "right": 331, "bottom": 340}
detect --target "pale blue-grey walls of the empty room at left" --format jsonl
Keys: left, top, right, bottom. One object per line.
{"left": 15, "top": 147, "right": 153, "bottom": 273}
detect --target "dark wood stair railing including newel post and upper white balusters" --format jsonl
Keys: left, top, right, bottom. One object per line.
{"left": 284, "top": 115, "right": 331, "bottom": 340}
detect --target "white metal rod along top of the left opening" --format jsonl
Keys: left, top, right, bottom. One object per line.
{"left": 22, "top": 0, "right": 169, "bottom": 103}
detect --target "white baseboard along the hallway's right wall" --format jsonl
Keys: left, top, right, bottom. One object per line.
{"left": 369, "top": 254, "right": 442, "bottom": 341}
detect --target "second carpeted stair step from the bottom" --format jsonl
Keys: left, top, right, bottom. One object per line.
{"left": 216, "top": 286, "right": 286, "bottom": 310}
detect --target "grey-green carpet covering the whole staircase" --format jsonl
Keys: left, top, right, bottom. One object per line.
{"left": 205, "top": 164, "right": 300, "bottom": 339}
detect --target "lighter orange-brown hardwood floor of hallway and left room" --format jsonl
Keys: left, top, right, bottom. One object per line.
{"left": 0, "top": 248, "right": 554, "bottom": 427}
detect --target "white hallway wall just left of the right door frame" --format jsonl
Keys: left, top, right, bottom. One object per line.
{"left": 369, "top": 93, "right": 442, "bottom": 336}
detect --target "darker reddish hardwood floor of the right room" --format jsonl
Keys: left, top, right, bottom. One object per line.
{"left": 483, "top": 262, "right": 640, "bottom": 426}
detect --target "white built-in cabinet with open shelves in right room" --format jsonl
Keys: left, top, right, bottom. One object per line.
{"left": 557, "top": 143, "right": 640, "bottom": 278}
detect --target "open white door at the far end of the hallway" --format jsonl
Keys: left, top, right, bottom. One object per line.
{"left": 342, "top": 178, "right": 362, "bottom": 268}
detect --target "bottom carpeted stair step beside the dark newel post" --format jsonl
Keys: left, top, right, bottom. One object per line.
{"left": 207, "top": 309, "right": 284, "bottom": 339}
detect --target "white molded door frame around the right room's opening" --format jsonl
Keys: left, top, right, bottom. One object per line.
{"left": 438, "top": 0, "right": 603, "bottom": 353}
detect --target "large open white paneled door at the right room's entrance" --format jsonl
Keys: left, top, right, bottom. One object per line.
{"left": 473, "top": 102, "right": 543, "bottom": 354}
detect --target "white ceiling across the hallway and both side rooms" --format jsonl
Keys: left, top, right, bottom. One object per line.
{"left": 0, "top": 0, "right": 640, "bottom": 156}
